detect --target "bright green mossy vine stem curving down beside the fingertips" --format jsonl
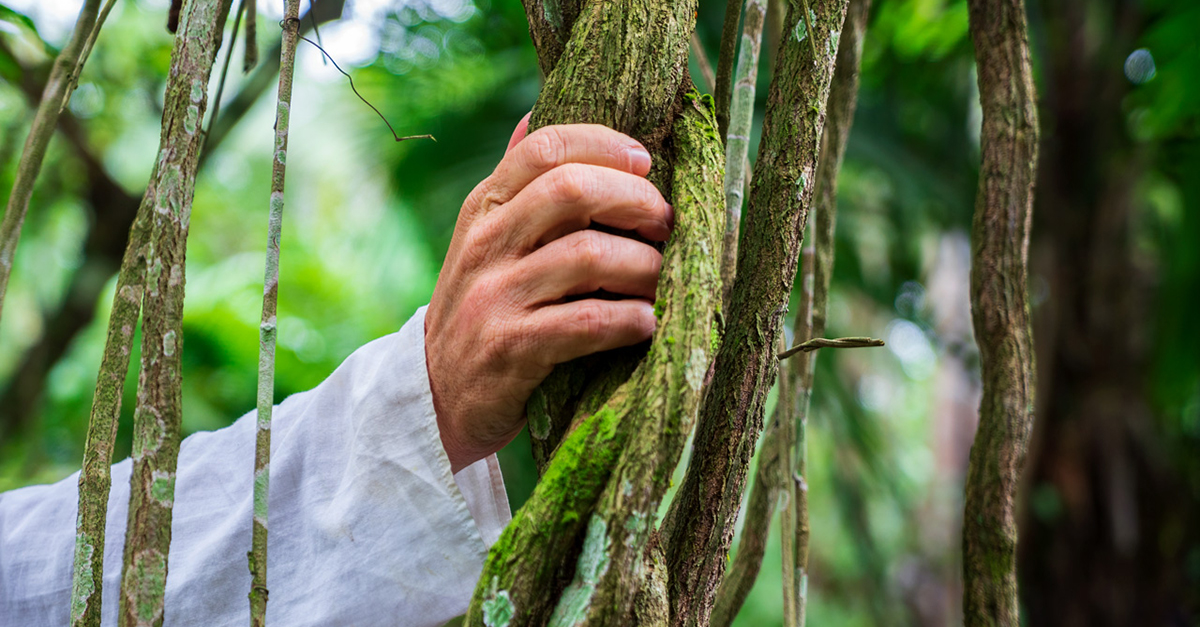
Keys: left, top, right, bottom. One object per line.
{"left": 467, "top": 97, "right": 724, "bottom": 625}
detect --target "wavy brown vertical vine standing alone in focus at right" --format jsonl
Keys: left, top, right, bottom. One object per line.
{"left": 962, "top": 0, "right": 1038, "bottom": 627}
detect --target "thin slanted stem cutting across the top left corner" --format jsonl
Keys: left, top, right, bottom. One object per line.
{"left": 0, "top": 0, "right": 107, "bottom": 321}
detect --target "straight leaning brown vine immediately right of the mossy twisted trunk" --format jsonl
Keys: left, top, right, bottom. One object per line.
{"left": 664, "top": 0, "right": 846, "bottom": 625}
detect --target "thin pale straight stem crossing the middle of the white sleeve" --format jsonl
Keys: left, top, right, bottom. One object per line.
{"left": 248, "top": 0, "right": 300, "bottom": 627}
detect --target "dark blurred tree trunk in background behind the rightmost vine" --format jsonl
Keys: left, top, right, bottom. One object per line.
{"left": 1020, "top": 0, "right": 1200, "bottom": 627}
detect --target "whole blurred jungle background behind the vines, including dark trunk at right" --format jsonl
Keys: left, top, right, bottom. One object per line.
{"left": 0, "top": 0, "right": 1200, "bottom": 626}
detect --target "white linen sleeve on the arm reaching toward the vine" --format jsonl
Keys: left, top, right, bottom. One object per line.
{"left": 0, "top": 307, "right": 510, "bottom": 627}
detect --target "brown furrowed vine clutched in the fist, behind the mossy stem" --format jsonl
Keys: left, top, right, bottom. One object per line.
{"left": 526, "top": 0, "right": 695, "bottom": 472}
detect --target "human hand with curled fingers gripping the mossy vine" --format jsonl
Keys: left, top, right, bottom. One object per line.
{"left": 425, "top": 115, "right": 673, "bottom": 472}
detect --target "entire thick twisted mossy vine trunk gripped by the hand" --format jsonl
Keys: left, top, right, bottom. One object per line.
{"left": 467, "top": 0, "right": 724, "bottom": 625}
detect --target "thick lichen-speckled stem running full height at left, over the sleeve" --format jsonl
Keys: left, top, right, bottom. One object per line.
{"left": 118, "top": 0, "right": 228, "bottom": 627}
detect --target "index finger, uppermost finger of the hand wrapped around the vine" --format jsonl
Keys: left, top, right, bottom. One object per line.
{"left": 487, "top": 124, "right": 650, "bottom": 203}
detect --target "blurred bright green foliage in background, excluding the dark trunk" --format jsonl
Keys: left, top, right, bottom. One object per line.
{"left": 0, "top": 0, "right": 1200, "bottom": 626}
